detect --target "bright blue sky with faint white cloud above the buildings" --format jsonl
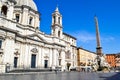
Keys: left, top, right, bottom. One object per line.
{"left": 34, "top": 0, "right": 120, "bottom": 54}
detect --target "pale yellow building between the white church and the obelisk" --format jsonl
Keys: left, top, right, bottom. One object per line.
{"left": 77, "top": 47, "right": 97, "bottom": 69}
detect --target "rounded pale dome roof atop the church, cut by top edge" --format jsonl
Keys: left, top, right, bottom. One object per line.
{"left": 16, "top": 0, "right": 37, "bottom": 11}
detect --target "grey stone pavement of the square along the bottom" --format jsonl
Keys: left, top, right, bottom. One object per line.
{"left": 0, "top": 72, "right": 120, "bottom": 80}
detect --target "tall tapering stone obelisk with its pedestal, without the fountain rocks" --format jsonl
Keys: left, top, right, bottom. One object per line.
{"left": 94, "top": 16, "right": 102, "bottom": 56}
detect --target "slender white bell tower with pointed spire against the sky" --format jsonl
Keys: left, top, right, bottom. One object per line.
{"left": 51, "top": 7, "right": 63, "bottom": 38}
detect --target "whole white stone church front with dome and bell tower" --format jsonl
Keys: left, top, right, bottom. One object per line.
{"left": 0, "top": 0, "right": 77, "bottom": 72}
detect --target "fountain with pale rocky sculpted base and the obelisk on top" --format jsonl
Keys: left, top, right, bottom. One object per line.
{"left": 94, "top": 16, "right": 109, "bottom": 71}
